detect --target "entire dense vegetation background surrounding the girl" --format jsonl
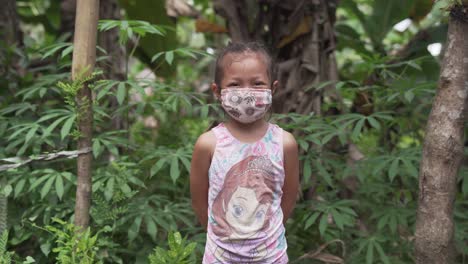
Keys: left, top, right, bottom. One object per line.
{"left": 0, "top": 0, "right": 468, "bottom": 263}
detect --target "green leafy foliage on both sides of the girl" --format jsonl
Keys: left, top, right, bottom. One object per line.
{"left": 0, "top": 0, "right": 468, "bottom": 264}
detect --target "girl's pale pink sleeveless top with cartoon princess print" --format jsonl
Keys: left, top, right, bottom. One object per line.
{"left": 203, "top": 123, "right": 288, "bottom": 264}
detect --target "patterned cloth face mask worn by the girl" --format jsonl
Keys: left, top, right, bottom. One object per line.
{"left": 221, "top": 88, "right": 272, "bottom": 124}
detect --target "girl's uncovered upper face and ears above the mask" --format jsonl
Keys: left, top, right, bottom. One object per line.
{"left": 212, "top": 52, "right": 278, "bottom": 95}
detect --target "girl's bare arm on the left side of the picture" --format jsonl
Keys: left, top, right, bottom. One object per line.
{"left": 190, "top": 131, "right": 216, "bottom": 230}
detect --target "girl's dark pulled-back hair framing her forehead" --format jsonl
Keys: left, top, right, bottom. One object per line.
{"left": 214, "top": 42, "right": 274, "bottom": 87}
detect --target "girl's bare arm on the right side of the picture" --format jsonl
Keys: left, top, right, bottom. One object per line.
{"left": 281, "top": 131, "right": 299, "bottom": 223}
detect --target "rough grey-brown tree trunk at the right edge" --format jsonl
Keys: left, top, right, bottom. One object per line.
{"left": 415, "top": 1, "right": 468, "bottom": 264}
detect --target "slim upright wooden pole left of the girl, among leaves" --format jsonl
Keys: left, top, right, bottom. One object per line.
{"left": 72, "top": 0, "right": 99, "bottom": 227}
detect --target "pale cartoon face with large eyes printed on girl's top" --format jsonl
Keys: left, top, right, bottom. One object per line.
{"left": 224, "top": 187, "right": 270, "bottom": 239}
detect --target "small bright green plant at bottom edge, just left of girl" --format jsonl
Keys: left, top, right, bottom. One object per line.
{"left": 148, "top": 232, "right": 197, "bottom": 264}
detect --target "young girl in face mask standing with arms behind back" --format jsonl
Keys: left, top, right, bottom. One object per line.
{"left": 190, "top": 43, "right": 299, "bottom": 264}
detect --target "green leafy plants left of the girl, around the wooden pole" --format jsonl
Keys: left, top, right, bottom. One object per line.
{"left": 0, "top": 6, "right": 208, "bottom": 263}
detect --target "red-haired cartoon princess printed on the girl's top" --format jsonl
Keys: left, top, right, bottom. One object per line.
{"left": 211, "top": 156, "right": 276, "bottom": 261}
